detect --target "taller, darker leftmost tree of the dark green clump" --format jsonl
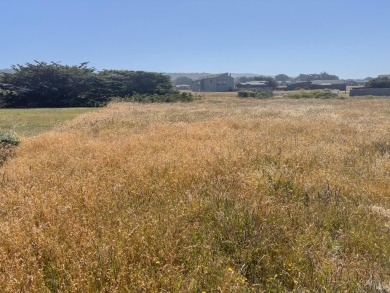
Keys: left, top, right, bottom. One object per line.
{"left": 1, "top": 62, "right": 99, "bottom": 108}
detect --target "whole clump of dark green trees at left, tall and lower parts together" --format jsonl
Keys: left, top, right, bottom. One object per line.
{"left": 0, "top": 61, "right": 173, "bottom": 108}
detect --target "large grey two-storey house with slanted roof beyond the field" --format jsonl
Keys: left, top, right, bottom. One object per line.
{"left": 191, "top": 73, "right": 234, "bottom": 92}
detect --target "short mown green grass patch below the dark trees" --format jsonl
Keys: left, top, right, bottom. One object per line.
{"left": 0, "top": 108, "right": 97, "bottom": 136}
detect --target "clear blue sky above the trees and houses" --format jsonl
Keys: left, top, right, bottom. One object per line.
{"left": 0, "top": 0, "right": 390, "bottom": 78}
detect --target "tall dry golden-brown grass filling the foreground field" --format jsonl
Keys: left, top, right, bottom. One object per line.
{"left": 0, "top": 94, "right": 390, "bottom": 292}
